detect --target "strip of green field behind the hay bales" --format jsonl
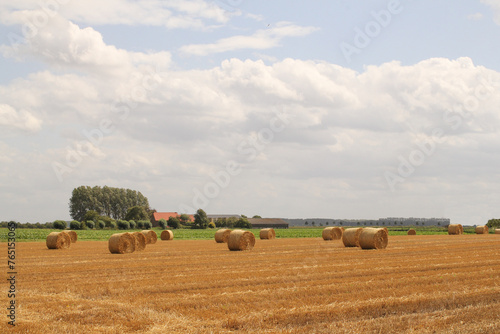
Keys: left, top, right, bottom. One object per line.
{"left": 0, "top": 226, "right": 480, "bottom": 242}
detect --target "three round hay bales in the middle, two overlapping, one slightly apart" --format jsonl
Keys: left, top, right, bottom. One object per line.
{"left": 214, "top": 228, "right": 276, "bottom": 251}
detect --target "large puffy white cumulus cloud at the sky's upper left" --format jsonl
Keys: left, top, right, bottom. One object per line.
{"left": 0, "top": 10, "right": 170, "bottom": 75}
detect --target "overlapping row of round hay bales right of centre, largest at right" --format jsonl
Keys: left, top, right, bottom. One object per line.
{"left": 322, "top": 227, "right": 389, "bottom": 249}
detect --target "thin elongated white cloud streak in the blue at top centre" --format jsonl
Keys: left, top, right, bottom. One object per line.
{"left": 180, "top": 22, "right": 318, "bottom": 56}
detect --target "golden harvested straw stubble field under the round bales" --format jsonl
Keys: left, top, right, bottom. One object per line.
{"left": 0, "top": 234, "right": 500, "bottom": 334}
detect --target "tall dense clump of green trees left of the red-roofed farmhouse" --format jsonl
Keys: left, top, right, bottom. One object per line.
{"left": 69, "top": 186, "right": 154, "bottom": 221}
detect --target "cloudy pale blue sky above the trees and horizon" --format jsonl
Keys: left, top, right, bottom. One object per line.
{"left": 0, "top": 0, "right": 500, "bottom": 225}
